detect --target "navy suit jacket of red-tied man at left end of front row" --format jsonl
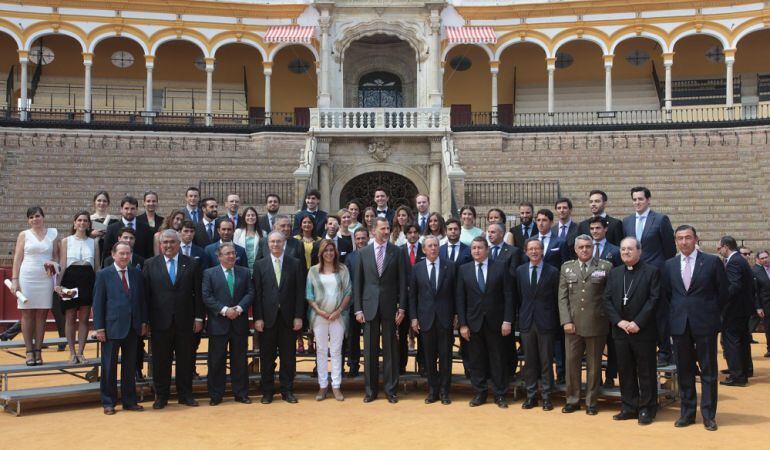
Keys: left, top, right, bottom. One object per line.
{"left": 93, "top": 264, "right": 147, "bottom": 339}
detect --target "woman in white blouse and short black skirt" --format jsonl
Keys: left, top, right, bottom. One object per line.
{"left": 54, "top": 211, "right": 99, "bottom": 364}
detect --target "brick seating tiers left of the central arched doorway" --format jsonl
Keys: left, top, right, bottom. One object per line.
{"left": 0, "top": 128, "right": 305, "bottom": 265}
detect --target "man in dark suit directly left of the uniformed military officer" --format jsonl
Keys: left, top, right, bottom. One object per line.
{"left": 516, "top": 238, "right": 561, "bottom": 411}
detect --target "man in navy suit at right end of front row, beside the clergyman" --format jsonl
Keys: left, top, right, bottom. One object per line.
{"left": 660, "top": 225, "right": 728, "bottom": 431}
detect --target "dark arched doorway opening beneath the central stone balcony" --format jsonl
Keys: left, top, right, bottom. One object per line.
{"left": 340, "top": 172, "right": 419, "bottom": 211}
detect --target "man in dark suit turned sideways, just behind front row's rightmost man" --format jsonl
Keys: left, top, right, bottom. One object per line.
{"left": 717, "top": 236, "right": 755, "bottom": 386}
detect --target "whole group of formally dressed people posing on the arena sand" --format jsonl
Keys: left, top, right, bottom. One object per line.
{"left": 11, "top": 183, "right": 770, "bottom": 430}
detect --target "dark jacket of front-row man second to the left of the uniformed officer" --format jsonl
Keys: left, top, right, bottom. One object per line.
{"left": 455, "top": 262, "right": 516, "bottom": 333}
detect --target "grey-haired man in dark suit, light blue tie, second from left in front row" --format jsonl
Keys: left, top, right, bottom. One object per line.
{"left": 143, "top": 230, "right": 205, "bottom": 409}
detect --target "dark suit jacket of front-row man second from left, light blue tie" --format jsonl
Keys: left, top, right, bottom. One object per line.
{"left": 142, "top": 252, "right": 205, "bottom": 333}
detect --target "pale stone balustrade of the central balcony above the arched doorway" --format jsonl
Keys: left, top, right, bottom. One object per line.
{"left": 310, "top": 108, "right": 449, "bottom": 134}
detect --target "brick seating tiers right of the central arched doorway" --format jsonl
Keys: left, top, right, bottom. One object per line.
{"left": 455, "top": 128, "right": 770, "bottom": 250}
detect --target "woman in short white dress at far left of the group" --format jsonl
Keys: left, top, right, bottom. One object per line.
{"left": 11, "top": 206, "right": 59, "bottom": 366}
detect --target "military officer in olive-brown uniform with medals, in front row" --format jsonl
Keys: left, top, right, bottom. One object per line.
{"left": 559, "top": 234, "right": 612, "bottom": 416}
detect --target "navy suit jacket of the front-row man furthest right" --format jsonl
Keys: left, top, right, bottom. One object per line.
{"left": 661, "top": 251, "right": 728, "bottom": 336}
